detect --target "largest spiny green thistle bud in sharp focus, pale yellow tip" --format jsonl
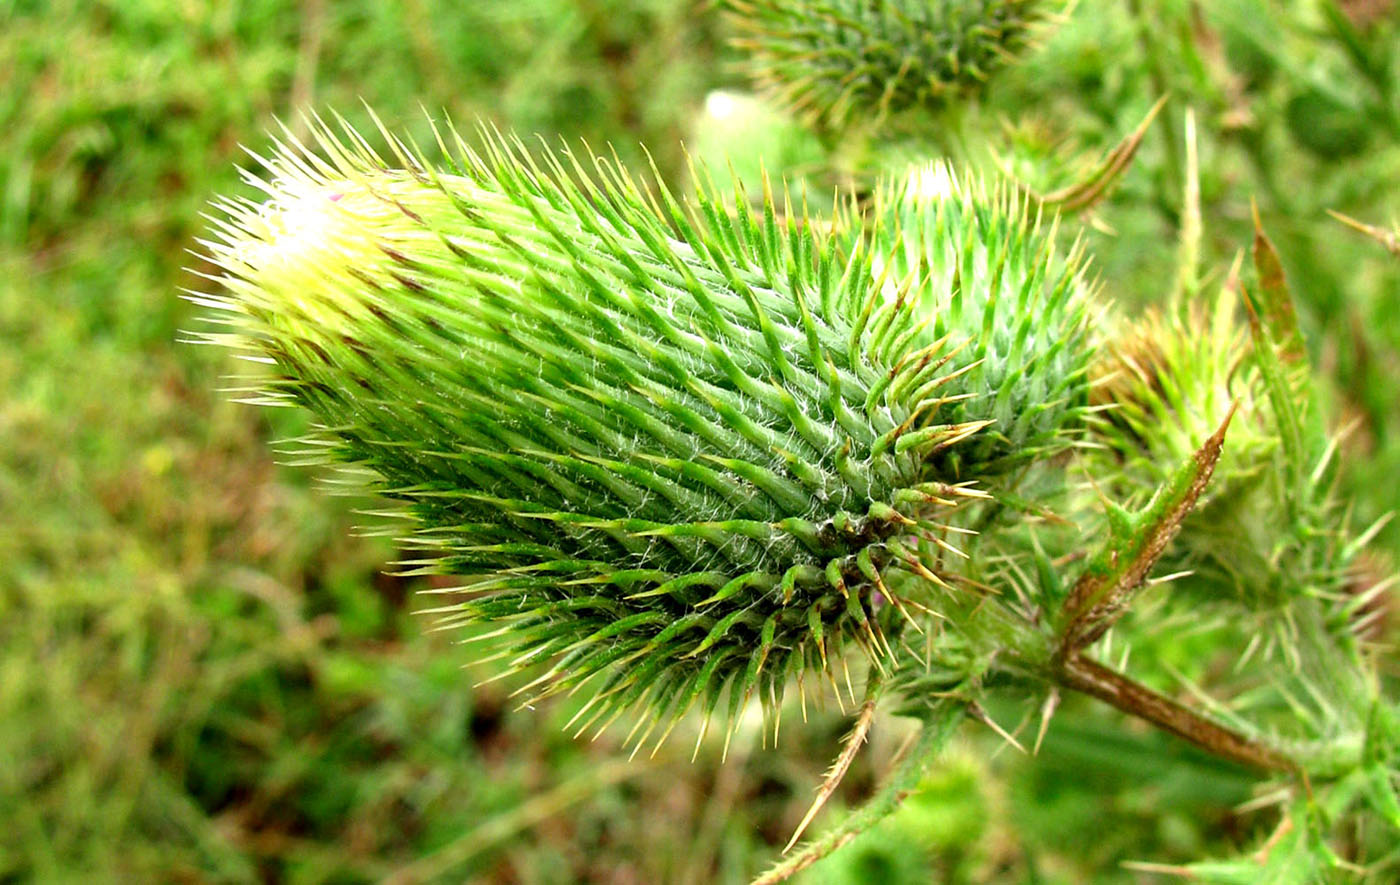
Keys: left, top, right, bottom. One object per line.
{"left": 189, "top": 121, "right": 1069, "bottom": 742}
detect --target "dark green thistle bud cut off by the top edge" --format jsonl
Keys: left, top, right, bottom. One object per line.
{"left": 722, "top": 0, "right": 1051, "bottom": 129}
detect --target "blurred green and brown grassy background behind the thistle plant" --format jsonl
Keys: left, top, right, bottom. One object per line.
{"left": 0, "top": 0, "right": 1400, "bottom": 885}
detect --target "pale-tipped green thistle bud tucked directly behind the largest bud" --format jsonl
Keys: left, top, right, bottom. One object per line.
{"left": 872, "top": 164, "right": 1093, "bottom": 476}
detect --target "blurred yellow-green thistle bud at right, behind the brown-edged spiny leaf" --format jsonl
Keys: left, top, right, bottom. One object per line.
{"left": 1089, "top": 286, "right": 1358, "bottom": 624}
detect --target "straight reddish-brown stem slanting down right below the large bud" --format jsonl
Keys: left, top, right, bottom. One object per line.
{"left": 1057, "top": 654, "right": 1298, "bottom": 772}
